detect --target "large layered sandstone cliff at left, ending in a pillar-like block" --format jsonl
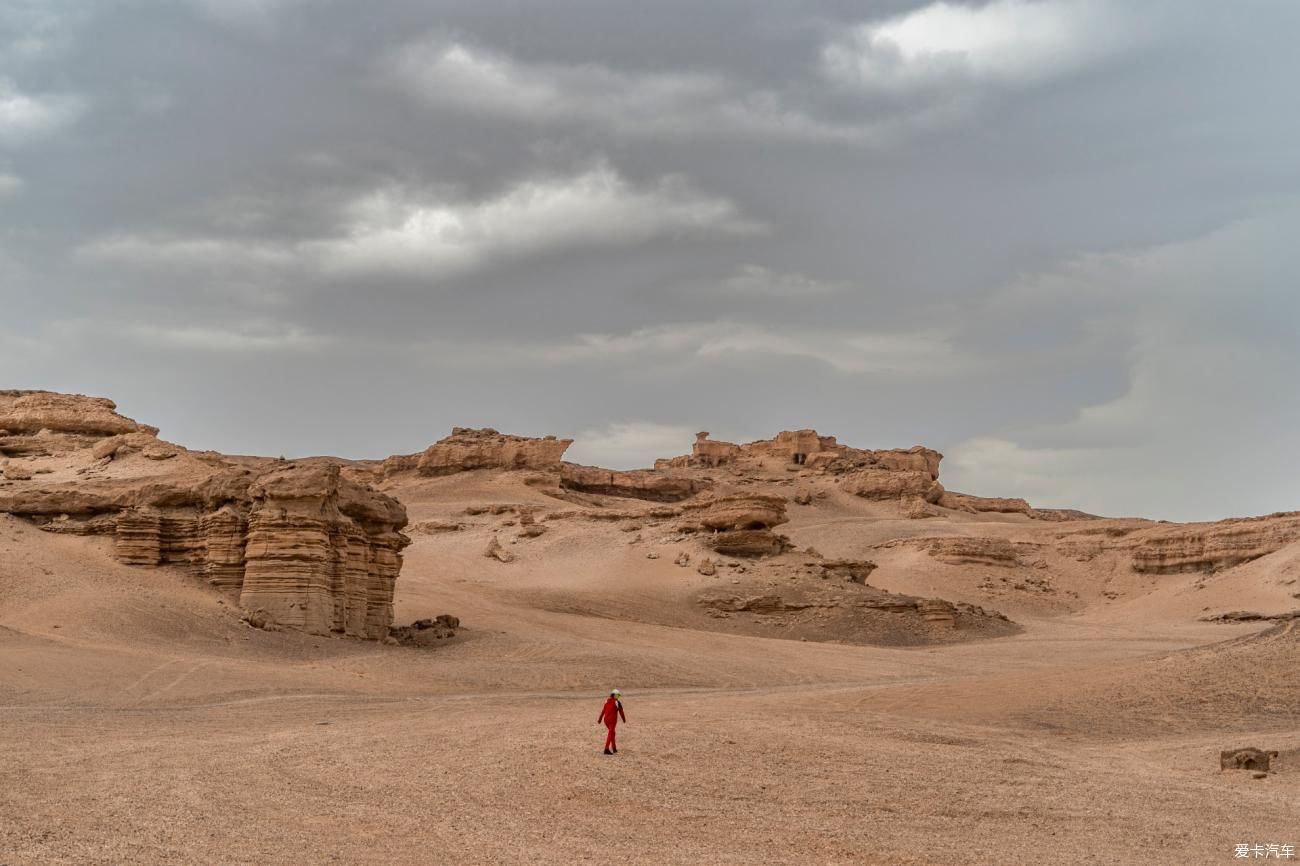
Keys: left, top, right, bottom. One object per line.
{"left": 0, "top": 391, "right": 408, "bottom": 640}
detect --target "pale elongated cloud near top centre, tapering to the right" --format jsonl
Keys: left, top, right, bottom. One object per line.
{"left": 389, "top": 38, "right": 880, "bottom": 140}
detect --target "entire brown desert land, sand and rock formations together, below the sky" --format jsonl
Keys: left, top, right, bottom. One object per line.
{"left": 0, "top": 391, "right": 1300, "bottom": 866}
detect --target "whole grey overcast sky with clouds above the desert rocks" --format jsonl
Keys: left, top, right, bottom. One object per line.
{"left": 0, "top": 0, "right": 1300, "bottom": 519}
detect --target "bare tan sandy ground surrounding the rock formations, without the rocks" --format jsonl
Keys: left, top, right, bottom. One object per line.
{"left": 0, "top": 479, "right": 1300, "bottom": 866}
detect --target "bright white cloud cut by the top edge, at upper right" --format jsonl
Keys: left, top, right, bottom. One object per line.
{"left": 822, "top": 0, "right": 1125, "bottom": 91}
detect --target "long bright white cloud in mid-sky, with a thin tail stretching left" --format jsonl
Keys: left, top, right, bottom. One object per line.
{"left": 77, "top": 165, "right": 766, "bottom": 278}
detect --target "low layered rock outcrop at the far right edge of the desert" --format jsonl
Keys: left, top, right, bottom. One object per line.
{"left": 1125, "top": 512, "right": 1300, "bottom": 575}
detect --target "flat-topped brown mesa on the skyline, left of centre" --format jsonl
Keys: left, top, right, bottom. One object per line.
{"left": 384, "top": 426, "right": 573, "bottom": 476}
